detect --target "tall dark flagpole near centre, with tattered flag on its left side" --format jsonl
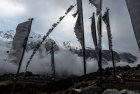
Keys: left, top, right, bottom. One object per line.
{"left": 77, "top": 0, "right": 86, "bottom": 81}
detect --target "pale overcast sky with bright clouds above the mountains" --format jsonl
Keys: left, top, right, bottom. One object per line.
{"left": 0, "top": 0, "right": 139, "bottom": 53}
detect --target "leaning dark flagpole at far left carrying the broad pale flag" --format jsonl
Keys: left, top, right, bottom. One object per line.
{"left": 11, "top": 18, "right": 33, "bottom": 94}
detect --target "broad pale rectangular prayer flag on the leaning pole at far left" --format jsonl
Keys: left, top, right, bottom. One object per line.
{"left": 8, "top": 21, "right": 31, "bottom": 64}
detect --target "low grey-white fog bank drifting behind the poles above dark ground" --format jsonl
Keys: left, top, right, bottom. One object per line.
{"left": 0, "top": 40, "right": 140, "bottom": 75}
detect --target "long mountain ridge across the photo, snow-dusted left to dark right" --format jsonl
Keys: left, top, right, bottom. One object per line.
{"left": 0, "top": 30, "right": 137, "bottom": 63}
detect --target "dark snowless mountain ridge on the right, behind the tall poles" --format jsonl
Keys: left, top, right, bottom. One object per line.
{"left": 73, "top": 49, "right": 137, "bottom": 63}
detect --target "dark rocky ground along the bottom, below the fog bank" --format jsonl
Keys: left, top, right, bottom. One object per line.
{"left": 0, "top": 65, "right": 140, "bottom": 94}
